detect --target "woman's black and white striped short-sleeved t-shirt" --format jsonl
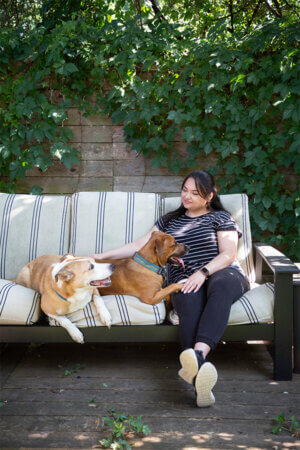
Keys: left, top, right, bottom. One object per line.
{"left": 155, "top": 211, "right": 244, "bottom": 283}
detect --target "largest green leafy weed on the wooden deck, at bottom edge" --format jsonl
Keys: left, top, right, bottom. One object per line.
{"left": 99, "top": 408, "right": 151, "bottom": 450}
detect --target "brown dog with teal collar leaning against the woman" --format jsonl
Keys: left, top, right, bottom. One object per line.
{"left": 98, "top": 231, "right": 188, "bottom": 305}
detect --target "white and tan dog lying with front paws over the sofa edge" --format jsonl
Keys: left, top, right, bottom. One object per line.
{"left": 15, "top": 255, "right": 114, "bottom": 344}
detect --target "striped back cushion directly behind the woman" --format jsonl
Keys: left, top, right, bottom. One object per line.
{"left": 162, "top": 194, "right": 255, "bottom": 283}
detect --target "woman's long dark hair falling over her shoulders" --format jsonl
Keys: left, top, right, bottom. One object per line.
{"left": 162, "top": 170, "right": 226, "bottom": 226}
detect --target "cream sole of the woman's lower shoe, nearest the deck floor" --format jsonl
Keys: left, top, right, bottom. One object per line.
{"left": 195, "top": 362, "right": 218, "bottom": 408}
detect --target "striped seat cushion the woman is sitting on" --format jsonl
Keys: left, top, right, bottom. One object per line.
{"left": 169, "top": 283, "right": 274, "bottom": 325}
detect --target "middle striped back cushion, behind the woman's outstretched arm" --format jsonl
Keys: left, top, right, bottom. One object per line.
{"left": 70, "top": 192, "right": 160, "bottom": 256}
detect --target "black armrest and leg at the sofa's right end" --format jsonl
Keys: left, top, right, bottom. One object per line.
{"left": 254, "top": 243, "right": 299, "bottom": 380}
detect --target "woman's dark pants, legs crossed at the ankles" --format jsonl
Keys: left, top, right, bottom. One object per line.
{"left": 172, "top": 267, "right": 249, "bottom": 350}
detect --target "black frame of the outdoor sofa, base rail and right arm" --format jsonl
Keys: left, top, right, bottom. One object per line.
{"left": 0, "top": 243, "right": 299, "bottom": 380}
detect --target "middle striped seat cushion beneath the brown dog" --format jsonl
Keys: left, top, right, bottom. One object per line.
{"left": 50, "top": 295, "right": 166, "bottom": 327}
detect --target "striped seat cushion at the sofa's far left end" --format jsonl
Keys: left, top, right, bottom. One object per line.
{"left": 0, "top": 280, "right": 41, "bottom": 325}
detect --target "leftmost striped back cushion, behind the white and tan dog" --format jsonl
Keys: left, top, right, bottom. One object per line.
{"left": 0, "top": 193, "right": 70, "bottom": 279}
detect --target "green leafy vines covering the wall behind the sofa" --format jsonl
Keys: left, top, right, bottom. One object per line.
{"left": 0, "top": 0, "right": 300, "bottom": 258}
